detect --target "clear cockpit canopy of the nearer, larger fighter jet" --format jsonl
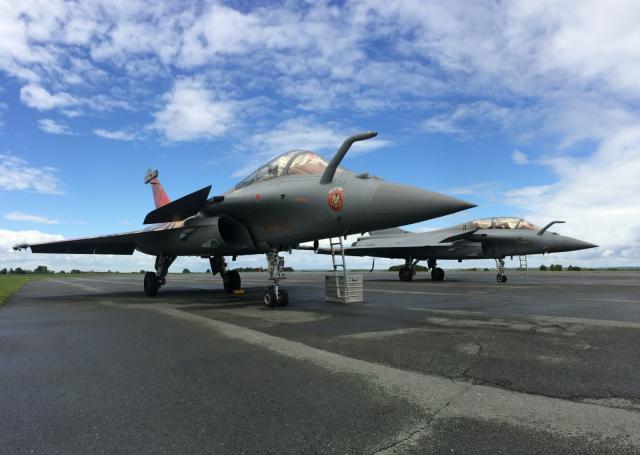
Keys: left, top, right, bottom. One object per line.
{"left": 234, "top": 150, "right": 345, "bottom": 190}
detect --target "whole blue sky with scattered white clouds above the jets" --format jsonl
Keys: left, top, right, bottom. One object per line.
{"left": 0, "top": 0, "right": 640, "bottom": 271}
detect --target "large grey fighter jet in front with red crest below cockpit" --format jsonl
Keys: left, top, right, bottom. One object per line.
{"left": 14, "top": 132, "right": 475, "bottom": 306}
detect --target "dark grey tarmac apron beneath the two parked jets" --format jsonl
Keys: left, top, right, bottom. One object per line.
{"left": 0, "top": 270, "right": 640, "bottom": 454}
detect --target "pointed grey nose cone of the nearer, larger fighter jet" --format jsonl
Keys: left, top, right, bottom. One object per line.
{"left": 372, "top": 182, "right": 476, "bottom": 226}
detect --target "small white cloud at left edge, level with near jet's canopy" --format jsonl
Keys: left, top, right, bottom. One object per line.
{"left": 0, "top": 154, "right": 62, "bottom": 194}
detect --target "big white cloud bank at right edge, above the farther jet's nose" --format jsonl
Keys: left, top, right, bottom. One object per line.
{"left": 507, "top": 127, "right": 640, "bottom": 264}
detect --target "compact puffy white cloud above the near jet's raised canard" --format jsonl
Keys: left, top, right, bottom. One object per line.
{"left": 152, "top": 79, "right": 237, "bottom": 141}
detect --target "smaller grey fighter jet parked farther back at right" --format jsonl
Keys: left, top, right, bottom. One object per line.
{"left": 312, "top": 217, "right": 597, "bottom": 283}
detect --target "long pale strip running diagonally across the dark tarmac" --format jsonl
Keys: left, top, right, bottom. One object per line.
{"left": 105, "top": 302, "right": 640, "bottom": 448}
